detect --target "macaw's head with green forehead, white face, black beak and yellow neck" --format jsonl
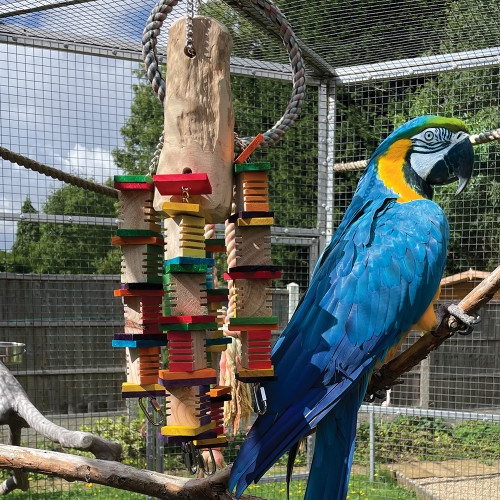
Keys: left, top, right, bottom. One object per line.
{"left": 370, "top": 116, "right": 474, "bottom": 201}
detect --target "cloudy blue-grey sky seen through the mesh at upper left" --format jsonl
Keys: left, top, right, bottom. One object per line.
{"left": 0, "top": 0, "right": 174, "bottom": 250}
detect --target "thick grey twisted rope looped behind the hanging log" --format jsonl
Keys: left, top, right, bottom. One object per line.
{"left": 142, "top": 0, "right": 306, "bottom": 150}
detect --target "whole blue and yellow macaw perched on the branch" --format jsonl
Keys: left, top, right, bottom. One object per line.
{"left": 229, "top": 116, "right": 474, "bottom": 500}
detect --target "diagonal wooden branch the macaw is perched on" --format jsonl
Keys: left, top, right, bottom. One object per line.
{"left": 366, "top": 266, "right": 500, "bottom": 395}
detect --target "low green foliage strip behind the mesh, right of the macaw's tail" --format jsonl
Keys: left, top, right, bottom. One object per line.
{"left": 355, "top": 416, "right": 500, "bottom": 464}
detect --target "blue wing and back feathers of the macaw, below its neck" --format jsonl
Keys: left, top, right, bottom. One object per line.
{"left": 229, "top": 190, "right": 448, "bottom": 498}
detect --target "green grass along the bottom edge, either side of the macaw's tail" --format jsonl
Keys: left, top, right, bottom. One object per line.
{"left": 246, "top": 474, "right": 417, "bottom": 500}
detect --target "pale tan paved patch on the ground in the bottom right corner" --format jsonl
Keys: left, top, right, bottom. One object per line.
{"left": 389, "top": 460, "right": 500, "bottom": 500}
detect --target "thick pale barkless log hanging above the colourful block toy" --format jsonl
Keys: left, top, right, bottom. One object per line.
{"left": 154, "top": 16, "right": 234, "bottom": 223}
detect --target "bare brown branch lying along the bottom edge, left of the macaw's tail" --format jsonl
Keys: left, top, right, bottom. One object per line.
{"left": 0, "top": 444, "right": 266, "bottom": 500}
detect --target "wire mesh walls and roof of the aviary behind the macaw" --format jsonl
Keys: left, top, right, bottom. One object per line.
{"left": 0, "top": 0, "right": 500, "bottom": 500}
